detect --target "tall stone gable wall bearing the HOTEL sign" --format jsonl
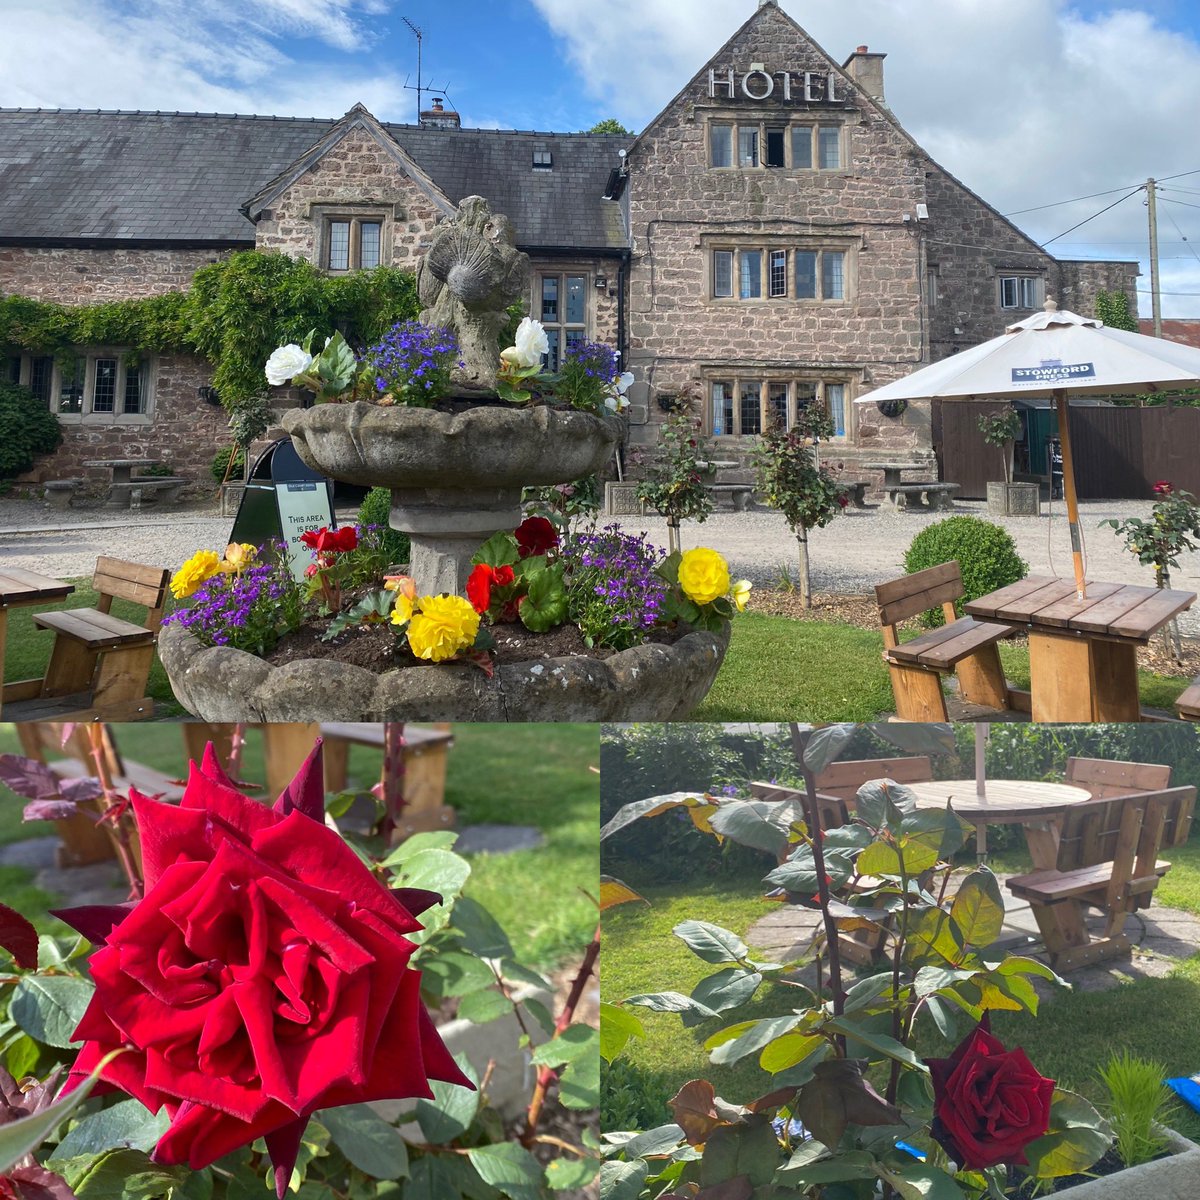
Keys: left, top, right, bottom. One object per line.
{"left": 629, "top": 5, "right": 930, "bottom": 470}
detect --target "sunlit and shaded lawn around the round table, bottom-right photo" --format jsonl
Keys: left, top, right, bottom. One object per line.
{"left": 601, "top": 842, "right": 1200, "bottom": 1139}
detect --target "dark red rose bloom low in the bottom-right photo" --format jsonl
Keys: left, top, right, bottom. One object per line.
{"left": 925, "top": 1025, "right": 1054, "bottom": 1171}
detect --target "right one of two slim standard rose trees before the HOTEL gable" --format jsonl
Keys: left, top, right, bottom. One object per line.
{"left": 752, "top": 412, "right": 847, "bottom": 608}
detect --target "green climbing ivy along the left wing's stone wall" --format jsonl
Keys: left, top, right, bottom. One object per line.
{"left": 0, "top": 250, "right": 420, "bottom": 413}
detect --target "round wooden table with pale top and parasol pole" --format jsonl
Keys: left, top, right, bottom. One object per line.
{"left": 905, "top": 779, "right": 1092, "bottom": 868}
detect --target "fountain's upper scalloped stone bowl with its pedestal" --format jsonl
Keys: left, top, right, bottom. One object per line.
{"left": 283, "top": 402, "right": 624, "bottom": 595}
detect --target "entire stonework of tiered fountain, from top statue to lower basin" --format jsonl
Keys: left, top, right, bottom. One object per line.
{"left": 160, "top": 196, "right": 728, "bottom": 721}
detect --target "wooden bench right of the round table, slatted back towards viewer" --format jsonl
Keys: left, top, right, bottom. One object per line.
{"left": 1007, "top": 787, "right": 1196, "bottom": 971}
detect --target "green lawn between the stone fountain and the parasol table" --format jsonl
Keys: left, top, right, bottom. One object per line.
{"left": 691, "top": 612, "right": 1188, "bottom": 721}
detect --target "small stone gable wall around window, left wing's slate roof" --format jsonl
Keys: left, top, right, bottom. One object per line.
{"left": 256, "top": 128, "right": 440, "bottom": 270}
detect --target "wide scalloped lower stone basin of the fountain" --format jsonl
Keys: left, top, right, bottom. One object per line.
{"left": 158, "top": 625, "right": 730, "bottom": 721}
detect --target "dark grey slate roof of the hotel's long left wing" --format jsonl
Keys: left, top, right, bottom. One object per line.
{"left": 0, "top": 109, "right": 632, "bottom": 250}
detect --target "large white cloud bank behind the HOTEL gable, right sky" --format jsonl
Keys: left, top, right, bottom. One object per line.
{"left": 533, "top": 0, "right": 1200, "bottom": 316}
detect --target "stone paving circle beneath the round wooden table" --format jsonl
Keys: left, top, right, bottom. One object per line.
{"left": 745, "top": 876, "right": 1200, "bottom": 996}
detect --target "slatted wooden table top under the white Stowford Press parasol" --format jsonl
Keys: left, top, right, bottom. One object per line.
{"left": 962, "top": 575, "right": 1196, "bottom": 642}
